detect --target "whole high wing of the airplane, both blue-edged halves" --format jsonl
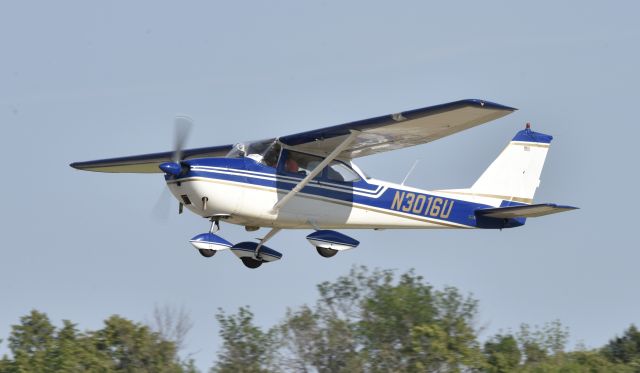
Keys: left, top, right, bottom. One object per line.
{"left": 70, "top": 100, "right": 516, "bottom": 173}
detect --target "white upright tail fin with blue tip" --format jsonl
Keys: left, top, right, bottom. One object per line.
{"left": 469, "top": 123, "right": 553, "bottom": 204}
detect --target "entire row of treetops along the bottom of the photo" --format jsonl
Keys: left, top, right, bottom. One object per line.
{"left": 0, "top": 267, "right": 640, "bottom": 373}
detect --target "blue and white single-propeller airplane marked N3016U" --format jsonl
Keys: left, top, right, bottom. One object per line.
{"left": 70, "top": 99, "right": 577, "bottom": 268}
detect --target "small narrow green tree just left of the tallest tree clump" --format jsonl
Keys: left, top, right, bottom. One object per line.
{"left": 211, "top": 307, "right": 275, "bottom": 373}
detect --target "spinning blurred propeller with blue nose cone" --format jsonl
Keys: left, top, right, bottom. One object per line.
{"left": 152, "top": 115, "right": 193, "bottom": 221}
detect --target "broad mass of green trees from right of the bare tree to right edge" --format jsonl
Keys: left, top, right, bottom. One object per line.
{"left": 213, "top": 267, "right": 640, "bottom": 373}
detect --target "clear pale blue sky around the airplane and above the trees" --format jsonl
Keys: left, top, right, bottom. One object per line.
{"left": 0, "top": 0, "right": 640, "bottom": 369}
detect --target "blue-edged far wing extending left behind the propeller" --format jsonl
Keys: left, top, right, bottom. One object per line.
{"left": 70, "top": 145, "right": 233, "bottom": 173}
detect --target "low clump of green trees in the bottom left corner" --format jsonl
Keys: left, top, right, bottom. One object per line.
{"left": 0, "top": 310, "right": 194, "bottom": 373}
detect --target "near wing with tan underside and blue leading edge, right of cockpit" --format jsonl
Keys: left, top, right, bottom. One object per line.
{"left": 280, "top": 100, "right": 516, "bottom": 159}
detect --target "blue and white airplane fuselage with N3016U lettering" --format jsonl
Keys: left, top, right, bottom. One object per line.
{"left": 166, "top": 157, "right": 524, "bottom": 229}
